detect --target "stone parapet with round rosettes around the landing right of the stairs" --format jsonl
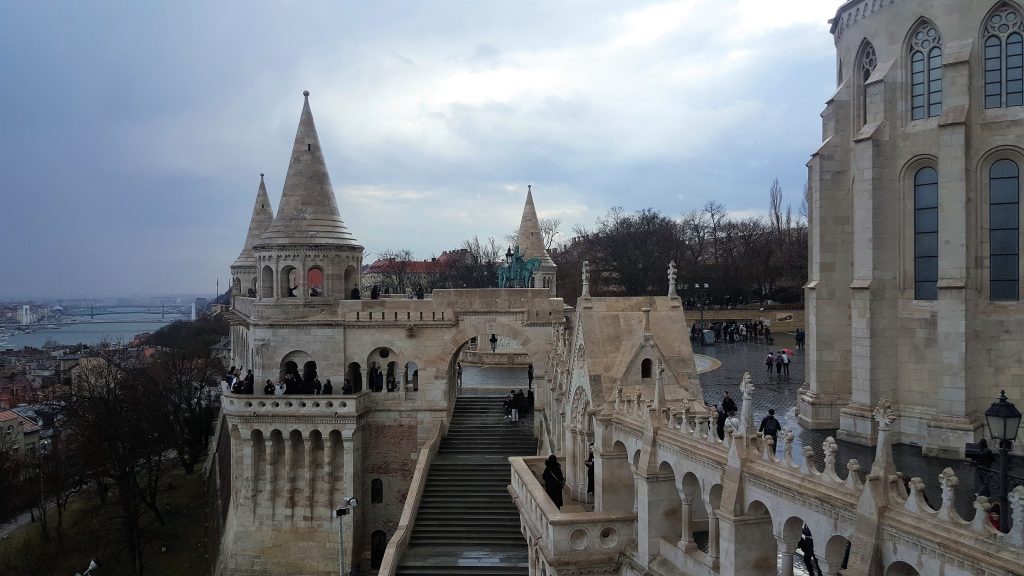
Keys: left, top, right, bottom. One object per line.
{"left": 509, "top": 456, "right": 637, "bottom": 569}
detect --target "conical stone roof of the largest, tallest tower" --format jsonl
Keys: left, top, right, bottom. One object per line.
{"left": 256, "top": 90, "right": 358, "bottom": 246}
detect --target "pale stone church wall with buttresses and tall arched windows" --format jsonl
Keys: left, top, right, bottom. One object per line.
{"left": 799, "top": 0, "right": 1024, "bottom": 455}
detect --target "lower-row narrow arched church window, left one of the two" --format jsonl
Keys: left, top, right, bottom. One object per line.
{"left": 913, "top": 167, "right": 939, "bottom": 300}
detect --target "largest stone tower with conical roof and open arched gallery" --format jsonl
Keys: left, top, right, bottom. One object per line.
{"left": 253, "top": 91, "right": 362, "bottom": 305}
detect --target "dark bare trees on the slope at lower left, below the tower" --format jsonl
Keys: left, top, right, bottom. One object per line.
{"left": 0, "top": 315, "right": 225, "bottom": 575}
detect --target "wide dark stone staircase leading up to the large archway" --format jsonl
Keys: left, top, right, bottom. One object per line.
{"left": 397, "top": 396, "right": 537, "bottom": 576}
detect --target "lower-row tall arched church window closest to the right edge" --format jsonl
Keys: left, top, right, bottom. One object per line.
{"left": 988, "top": 160, "right": 1020, "bottom": 300}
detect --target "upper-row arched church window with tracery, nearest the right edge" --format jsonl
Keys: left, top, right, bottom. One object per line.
{"left": 984, "top": 4, "right": 1024, "bottom": 108}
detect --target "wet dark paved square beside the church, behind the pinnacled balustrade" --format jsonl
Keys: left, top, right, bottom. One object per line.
{"left": 694, "top": 334, "right": 1024, "bottom": 519}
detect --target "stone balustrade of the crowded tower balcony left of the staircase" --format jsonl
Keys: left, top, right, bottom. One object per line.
{"left": 220, "top": 390, "right": 370, "bottom": 417}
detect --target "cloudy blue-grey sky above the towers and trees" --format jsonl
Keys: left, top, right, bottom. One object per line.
{"left": 0, "top": 0, "right": 840, "bottom": 297}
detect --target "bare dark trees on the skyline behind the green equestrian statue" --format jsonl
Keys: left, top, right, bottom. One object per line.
{"left": 364, "top": 179, "right": 807, "bottom": 305}
